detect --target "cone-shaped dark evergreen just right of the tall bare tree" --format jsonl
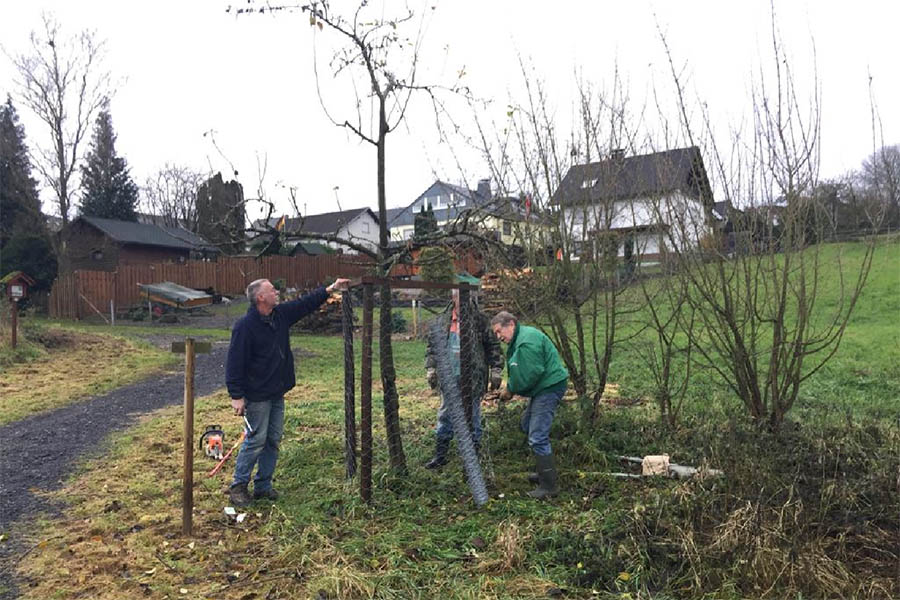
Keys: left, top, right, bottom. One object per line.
{"left": 81, "top": 109, "right": 138, "bottom": 221}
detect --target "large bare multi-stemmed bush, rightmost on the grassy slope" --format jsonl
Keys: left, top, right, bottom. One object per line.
{"left": 663, "top": 23, "right": 877, "bottom": 429}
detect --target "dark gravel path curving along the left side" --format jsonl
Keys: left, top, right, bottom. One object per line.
{"left": 0, "top": 334, "right": 228, "bottom": 600}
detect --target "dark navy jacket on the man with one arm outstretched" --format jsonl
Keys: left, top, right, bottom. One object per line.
{"left": 225, "top": 286, "right": 328, "bottom": 402}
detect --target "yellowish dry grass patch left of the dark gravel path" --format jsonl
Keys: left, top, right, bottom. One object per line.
{"left": 0, "top": 329, "right": 172, "bottom": 425}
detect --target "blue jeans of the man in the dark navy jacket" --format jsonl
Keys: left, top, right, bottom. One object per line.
{"left": 231, "top": 396, "right": 284, "bottom": 493}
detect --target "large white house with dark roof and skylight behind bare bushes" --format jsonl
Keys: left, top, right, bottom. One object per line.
{"left": 551, "top": 146, "right": 714, "bottom": 261}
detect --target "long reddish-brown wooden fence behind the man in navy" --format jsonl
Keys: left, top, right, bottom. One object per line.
{"left": 48, "top": 254, "right": 372, "bottom": 319}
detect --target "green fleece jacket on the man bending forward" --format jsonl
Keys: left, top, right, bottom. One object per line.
{"left": 506, "top": 323, "right": 569, "bottom": 398}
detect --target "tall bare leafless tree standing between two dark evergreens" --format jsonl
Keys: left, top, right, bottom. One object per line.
{"left": 11, "top": 14, "right": 111, "bottom": 225}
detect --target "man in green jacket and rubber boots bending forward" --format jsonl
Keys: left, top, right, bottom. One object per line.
{"left": 491, "top": 311, "right": 569, "bottom": 499}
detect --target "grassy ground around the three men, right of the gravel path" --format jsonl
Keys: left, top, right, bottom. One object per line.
{"left": 7, "top": 243, "right": 900, "bottom": 599}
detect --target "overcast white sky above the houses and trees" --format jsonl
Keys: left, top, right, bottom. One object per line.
{"left": 0, "top": 0, "right": 900, "bottom": 218}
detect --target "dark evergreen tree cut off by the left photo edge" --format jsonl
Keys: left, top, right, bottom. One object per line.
{"left": 0, "top": 96, "right": 44, "bottom": 250}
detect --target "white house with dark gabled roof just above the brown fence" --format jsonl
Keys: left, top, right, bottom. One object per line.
{"left": 254, "top": 208, "right": 378, "bottom": 254}
